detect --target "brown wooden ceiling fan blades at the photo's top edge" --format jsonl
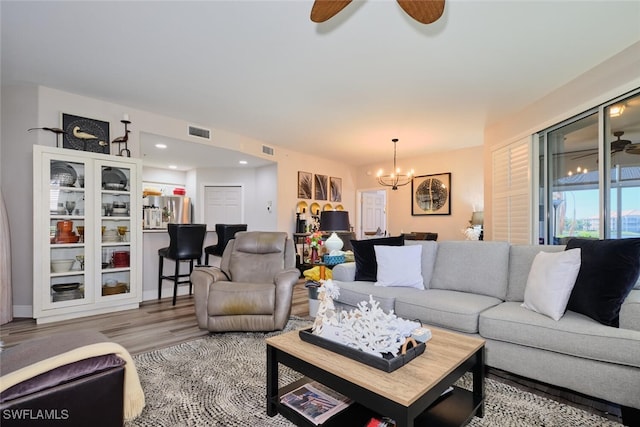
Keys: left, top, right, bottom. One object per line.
{"left": 311, "top": 0, "right": 445, "bottom": 24}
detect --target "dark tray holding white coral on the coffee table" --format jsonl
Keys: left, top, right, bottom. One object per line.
{"left": 299, "top": 328, "right": 427, "bottom": 372}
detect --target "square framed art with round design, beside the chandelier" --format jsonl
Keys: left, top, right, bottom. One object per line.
{"left": 411, "top": 172, "right": 451, "bottom": 215}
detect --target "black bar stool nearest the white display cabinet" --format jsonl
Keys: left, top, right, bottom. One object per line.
{"left": 158, "top": 224, "right": 207, "bottom": 305}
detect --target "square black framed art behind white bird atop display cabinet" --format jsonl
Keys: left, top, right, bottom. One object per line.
{"left": 62, "top": 113, "right": 110, "bottom": 154}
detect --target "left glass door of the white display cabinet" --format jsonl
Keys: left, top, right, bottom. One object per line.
{"left": 46, "top": 157, "right": 91, "bottom": 307}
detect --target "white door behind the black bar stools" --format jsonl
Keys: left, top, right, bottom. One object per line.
{"left": 204, "top": 185, "right": 243, "bottom": 230}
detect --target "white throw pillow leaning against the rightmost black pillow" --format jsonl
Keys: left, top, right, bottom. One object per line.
{"left": 522, "top": 248, "right": 580, "bottom": 320}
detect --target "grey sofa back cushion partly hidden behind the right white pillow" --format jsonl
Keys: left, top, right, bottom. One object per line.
{"left": 506, "top": 245, "right": 564, "bottom": 301}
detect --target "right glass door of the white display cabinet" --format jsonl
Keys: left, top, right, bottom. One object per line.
{"left": 96, "top": 162, "right": 135, "bottom": 298}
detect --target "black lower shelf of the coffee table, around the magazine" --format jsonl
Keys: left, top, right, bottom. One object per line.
{"left": 273, "top": 378, "right": 482, "bottom": 427}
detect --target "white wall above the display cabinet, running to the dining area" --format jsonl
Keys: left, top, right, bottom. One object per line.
{"left": 0, "top": 86, "right": 355, "bottom": 317}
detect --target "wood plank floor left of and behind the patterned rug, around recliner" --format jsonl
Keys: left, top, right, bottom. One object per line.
{"left": 0, "top": 280, "right": 309, "bottom": 354}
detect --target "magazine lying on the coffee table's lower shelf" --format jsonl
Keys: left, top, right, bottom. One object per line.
{"left": 280, "top": 381, "right": 353, "bottom": 425}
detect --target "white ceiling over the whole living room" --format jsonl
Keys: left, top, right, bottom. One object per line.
{"left": 0, "top": 0, "right": 640, "bottom": 165}
